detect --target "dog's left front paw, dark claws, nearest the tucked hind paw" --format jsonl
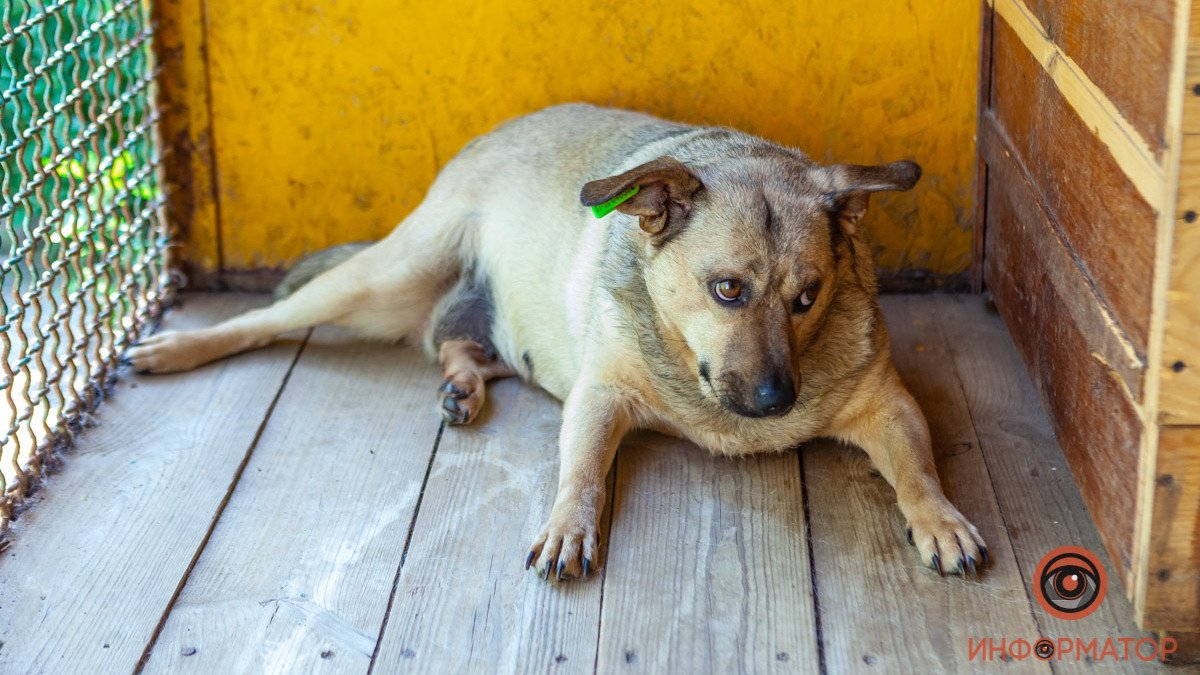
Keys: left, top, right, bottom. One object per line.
{"left": 526, "top": 504, "right": 596, "bottom": 581}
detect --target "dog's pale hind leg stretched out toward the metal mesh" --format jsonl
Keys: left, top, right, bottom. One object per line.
{"left": 127, "top": 204, "right": 469, "bottom": 372}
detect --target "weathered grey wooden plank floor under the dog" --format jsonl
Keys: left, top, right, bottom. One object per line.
{"left": 0, "top": 295, "right": 1166, "bottom": 674}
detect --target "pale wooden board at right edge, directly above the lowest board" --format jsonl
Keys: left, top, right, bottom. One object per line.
{"left": 1158, "top": 134, "right": 1200, "bottom": 424}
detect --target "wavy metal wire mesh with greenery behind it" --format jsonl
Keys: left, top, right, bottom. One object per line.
{"left": 0, "top": 0, "right": 169, "bottom": 535}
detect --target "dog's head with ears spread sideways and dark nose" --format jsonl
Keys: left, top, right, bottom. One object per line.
{"left": 581, "top": 150, "right": 920, "bottom": 417}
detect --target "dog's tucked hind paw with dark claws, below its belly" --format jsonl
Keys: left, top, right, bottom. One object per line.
{"left": 438, "top": 340, "right": 517, "bottom": 424}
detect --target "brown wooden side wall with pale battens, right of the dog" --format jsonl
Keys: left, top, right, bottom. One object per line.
{"left": 976, "top": 0, "right": 1200, "bottom": 632}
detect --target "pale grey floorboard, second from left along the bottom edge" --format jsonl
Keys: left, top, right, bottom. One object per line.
{"left": 138, "top": 328, "right": 442, "bottom": 673}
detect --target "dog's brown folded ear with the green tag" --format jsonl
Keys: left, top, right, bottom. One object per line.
{"left": 580, "top": 157, "right": 704, "bottom": 237}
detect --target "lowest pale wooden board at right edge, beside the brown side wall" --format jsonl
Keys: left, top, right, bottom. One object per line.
{"left": 1142, "top": 426, "right": 1200, "bottom": 632}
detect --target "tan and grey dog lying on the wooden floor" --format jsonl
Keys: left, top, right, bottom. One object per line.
{"left": 128, "top": 104, "right": 989, "bottom": 580}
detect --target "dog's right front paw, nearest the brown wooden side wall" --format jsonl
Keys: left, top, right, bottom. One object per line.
{"left": 908, "top": 501, "right": 990, "bottom": 577}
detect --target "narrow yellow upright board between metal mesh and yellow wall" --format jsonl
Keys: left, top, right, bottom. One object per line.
{"left": 150, "top": 0, "right": 222, "bottom": 288}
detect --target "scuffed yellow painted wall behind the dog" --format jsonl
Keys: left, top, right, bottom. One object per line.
{"left": 182, "top": 0, "right": 979, "bottom": 274}
